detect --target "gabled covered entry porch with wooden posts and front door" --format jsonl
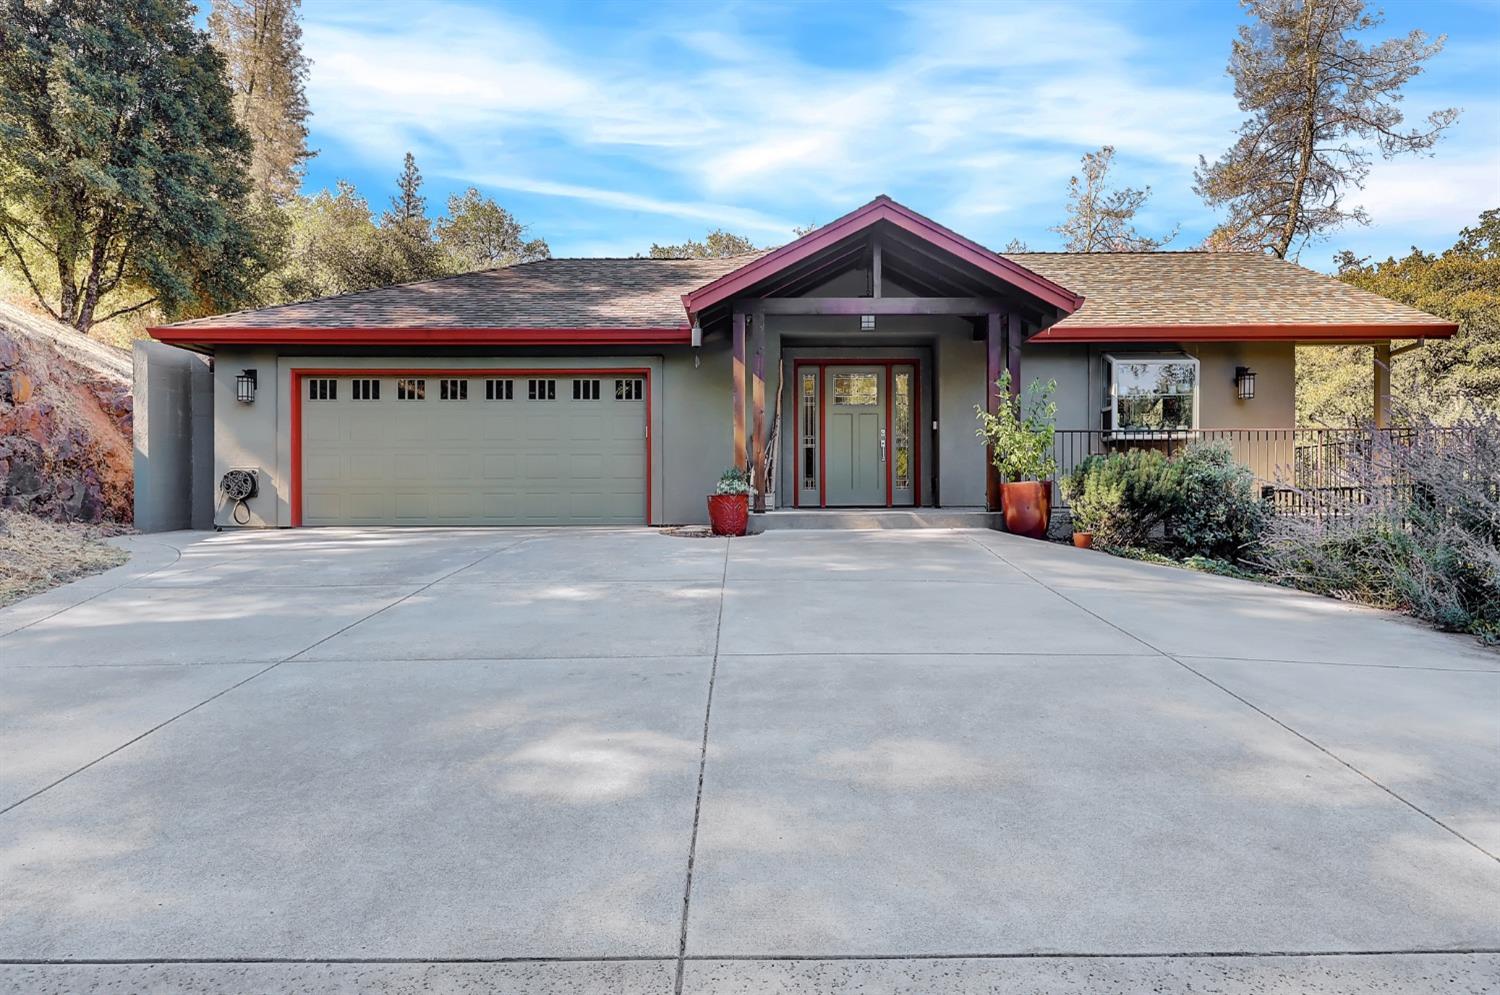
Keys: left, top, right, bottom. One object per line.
{"left": 684, "top": 198, "right": 1082, "bottom": 512}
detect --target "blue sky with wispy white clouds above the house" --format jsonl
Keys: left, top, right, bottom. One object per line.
{"left": 292, "top": 0, "right": 1500, "bottom": 269}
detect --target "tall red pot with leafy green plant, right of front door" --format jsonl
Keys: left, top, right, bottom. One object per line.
{"left": 975, "top": 371, "right": 1058, "bottom": 539}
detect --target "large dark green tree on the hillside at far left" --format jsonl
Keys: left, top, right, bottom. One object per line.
{"left": 0, "top": 0, "right": 264, "bottom": 333}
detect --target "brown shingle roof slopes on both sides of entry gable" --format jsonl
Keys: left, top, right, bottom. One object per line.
{"left": 164, "top": 252, "right": 1451, "bottom": 338}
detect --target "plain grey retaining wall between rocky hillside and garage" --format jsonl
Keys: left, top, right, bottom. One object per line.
{"left": 132, "top": 341, "right": 214, "bottom": 533}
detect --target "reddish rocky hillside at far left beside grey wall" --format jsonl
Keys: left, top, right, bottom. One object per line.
{"left": 0, "top": 302, "right": 134, "bottom": 522}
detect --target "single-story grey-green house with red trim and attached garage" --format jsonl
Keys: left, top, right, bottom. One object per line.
{"left": 141, "top": 197, "right": 1455, "bottom": 527}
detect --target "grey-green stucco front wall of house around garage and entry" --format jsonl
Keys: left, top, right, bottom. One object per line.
{"left": 196, "top": 330, "right": 1295, "bottom": 527}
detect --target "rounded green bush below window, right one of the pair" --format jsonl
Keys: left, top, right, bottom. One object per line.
{"left": 1170, "top": 443, "right": 1269, "bottom": 561}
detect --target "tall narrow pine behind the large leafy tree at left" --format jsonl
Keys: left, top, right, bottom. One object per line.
{"left": 209, "top": 0, "right": 314, "bottom": 204}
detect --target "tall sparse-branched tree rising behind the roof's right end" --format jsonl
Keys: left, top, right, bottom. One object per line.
{"left": 1194, "top": 0, "right": 1458, "bottom": 258}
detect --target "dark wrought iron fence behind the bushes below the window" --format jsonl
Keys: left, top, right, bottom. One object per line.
{"left": 1053, "top": 428, "right": 1464, "bottom": 515}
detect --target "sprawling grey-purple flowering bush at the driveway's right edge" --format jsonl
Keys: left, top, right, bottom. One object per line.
{"left": 1257, "top": 414, "right": 1500, "bottom": 642}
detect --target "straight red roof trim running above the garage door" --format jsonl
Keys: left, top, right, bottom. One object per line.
{"left": 147, "top": 326, "right": 693, "bottom": 345}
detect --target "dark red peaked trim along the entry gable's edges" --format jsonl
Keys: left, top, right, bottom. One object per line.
{"left": 683, "top": 194, "right": 1083, "bottom": 320}
